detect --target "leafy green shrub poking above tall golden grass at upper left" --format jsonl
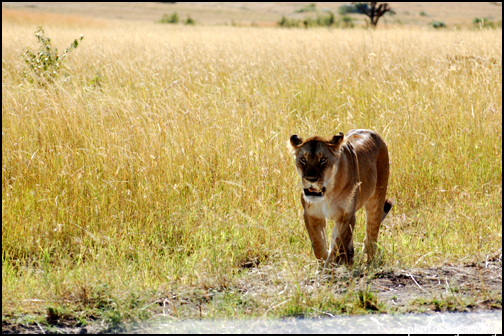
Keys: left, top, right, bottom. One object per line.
{"left": 19, "top": 26, "right": 84, "bottom": 83}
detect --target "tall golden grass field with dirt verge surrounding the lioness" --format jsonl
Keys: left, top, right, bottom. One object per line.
{"left": 2, "top": 2, "right": 502, "bottom": 332}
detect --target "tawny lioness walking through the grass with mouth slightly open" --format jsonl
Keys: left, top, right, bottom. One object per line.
{"left": 288, "top": 129, "right": 392, "bottom": 267}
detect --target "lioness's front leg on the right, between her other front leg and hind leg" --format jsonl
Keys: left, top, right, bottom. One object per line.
{"left": 324, "top": 214, "right": 355, "bottom": 268}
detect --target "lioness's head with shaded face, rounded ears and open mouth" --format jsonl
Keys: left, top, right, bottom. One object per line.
{"left": 289, "top": 132, "right": 344, "bottom": 201}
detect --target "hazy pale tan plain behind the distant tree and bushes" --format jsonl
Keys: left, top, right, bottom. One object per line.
{"left": 2, "top": 2, "right": 502, "bottom": 27}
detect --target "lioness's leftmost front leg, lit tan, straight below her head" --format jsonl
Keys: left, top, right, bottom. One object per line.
{"left": 301, "top": 195, "right": 328, "bottom": 261}
